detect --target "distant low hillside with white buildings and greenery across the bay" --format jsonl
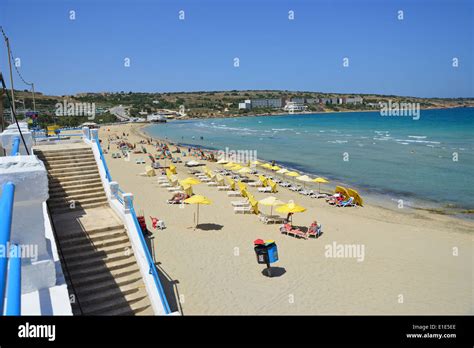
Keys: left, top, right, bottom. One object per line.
{"left": 0, "top": 90, "right": 474, "bottom": 127}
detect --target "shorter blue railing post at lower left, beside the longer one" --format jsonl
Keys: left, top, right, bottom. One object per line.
{"left": 6, "top": 244, "right": 21, "bottom": 316}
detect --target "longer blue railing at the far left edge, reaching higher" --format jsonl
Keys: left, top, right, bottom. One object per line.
{"left": 0, "top": 182, "right": 15, "bottom": 314}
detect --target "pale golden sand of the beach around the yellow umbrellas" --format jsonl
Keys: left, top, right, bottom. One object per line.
{"left": 99, "top": 124, "right": 474, "bottom": 315}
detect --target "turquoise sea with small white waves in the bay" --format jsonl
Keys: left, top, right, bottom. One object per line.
{"left": 145, "top": 108, "right": 474, "bottom": 217}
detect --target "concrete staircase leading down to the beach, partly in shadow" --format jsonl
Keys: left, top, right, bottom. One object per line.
{"left": 34, "top": 145, "right": 154, "bottom": 315}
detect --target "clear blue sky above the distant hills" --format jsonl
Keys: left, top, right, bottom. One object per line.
{"left": 0, "top": 0, "right": 474, "bottom": 97}
